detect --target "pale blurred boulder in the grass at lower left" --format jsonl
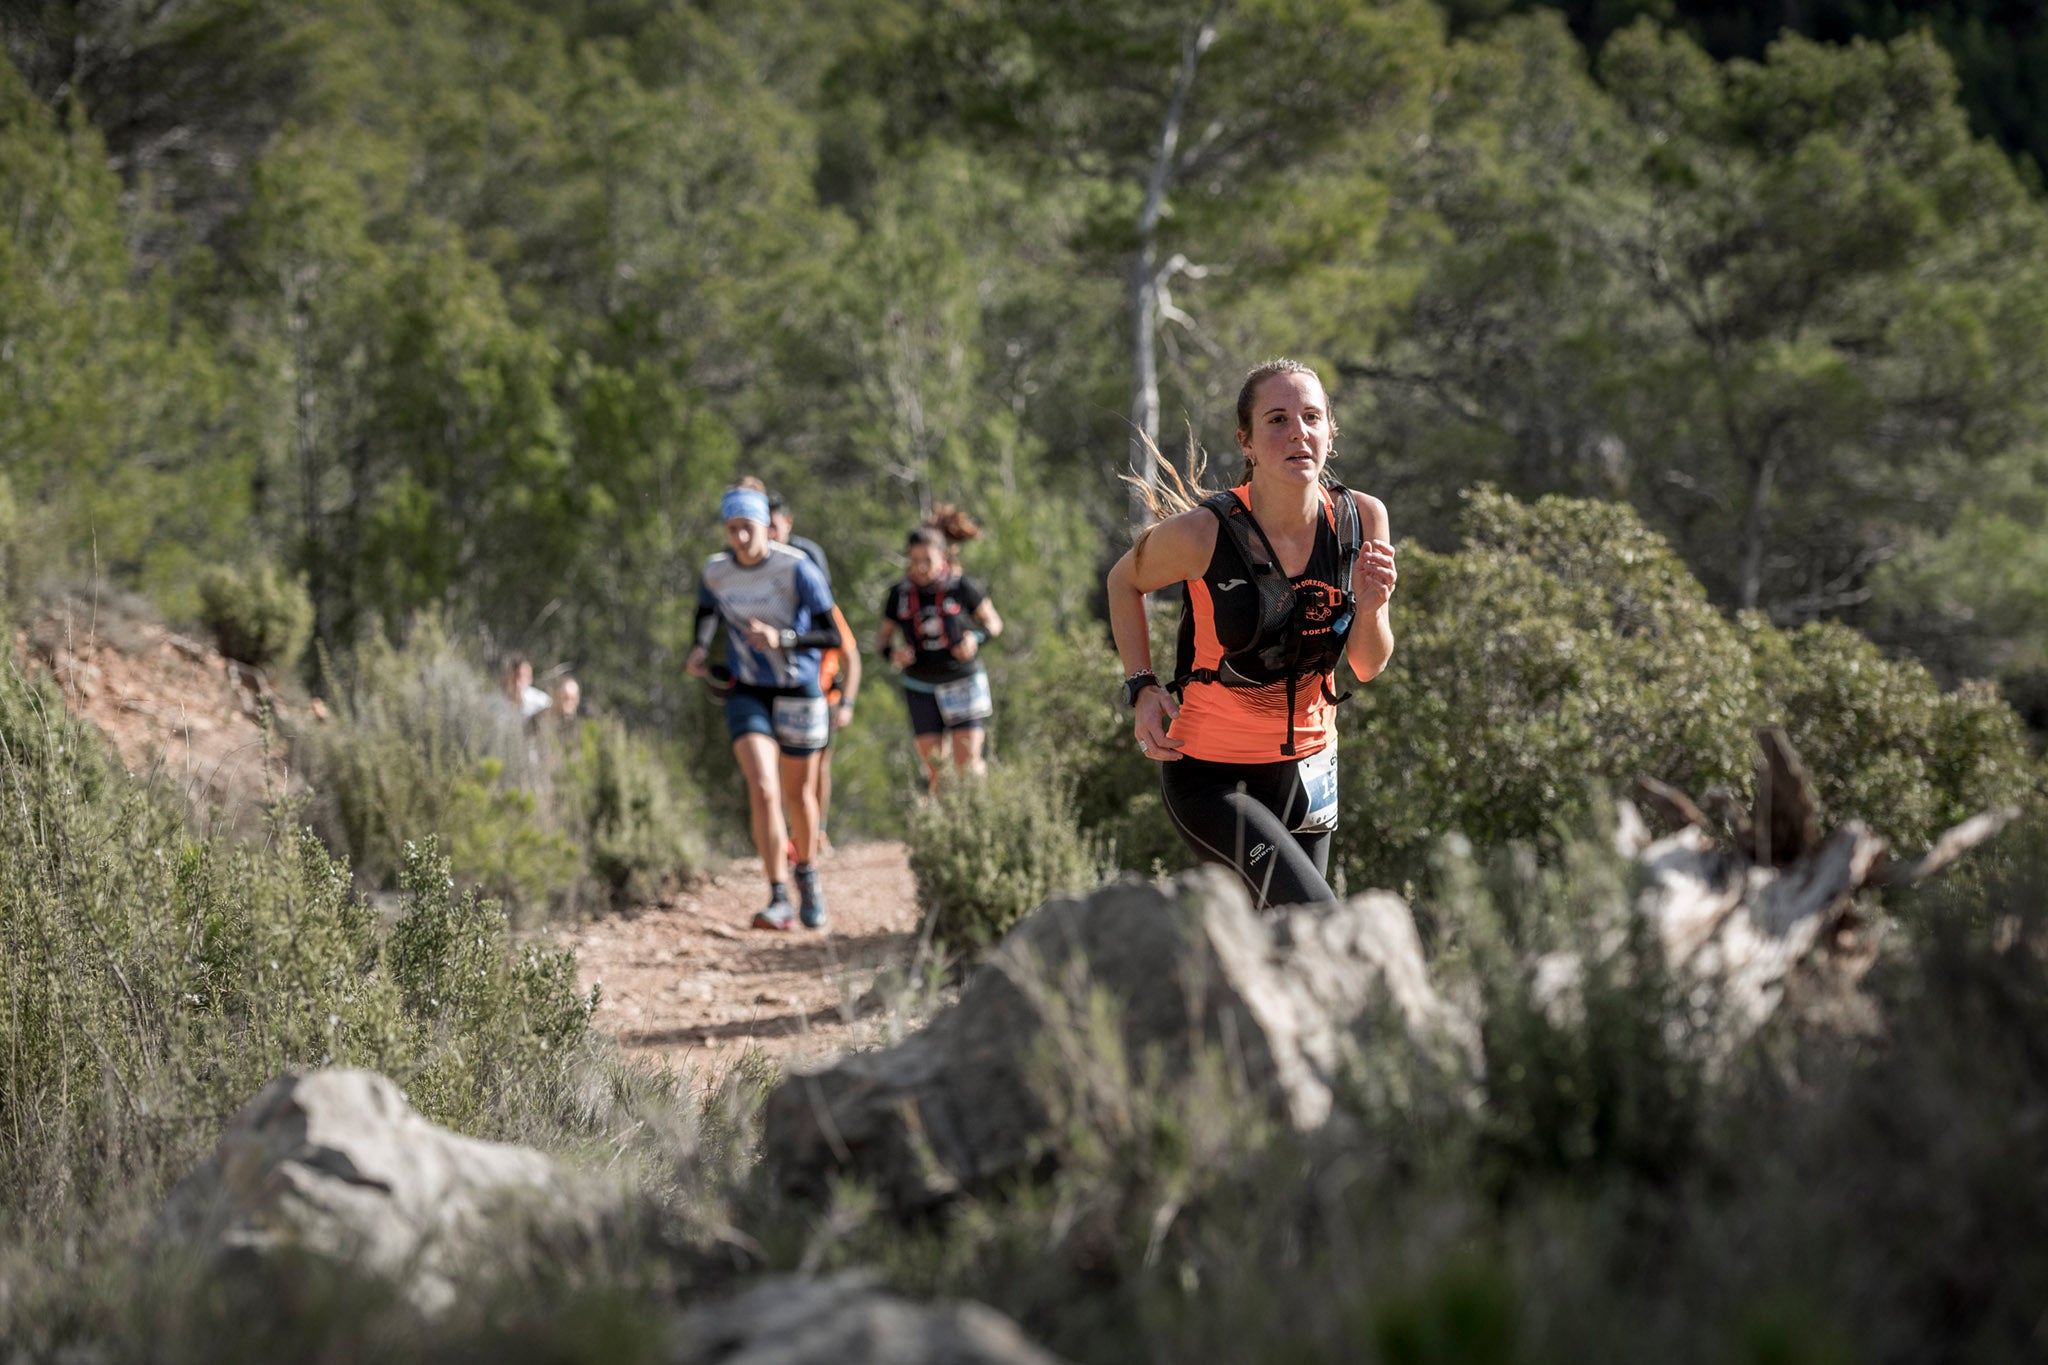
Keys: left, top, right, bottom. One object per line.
{"left": 152, "top": 1070, "right": 616, "bottom": 1312}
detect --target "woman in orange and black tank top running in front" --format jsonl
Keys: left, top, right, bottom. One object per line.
{"left": 1108, "top": 360, "right": 1397, "bottom": 909}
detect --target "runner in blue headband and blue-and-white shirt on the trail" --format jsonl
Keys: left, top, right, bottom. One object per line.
{"left": 684, "top": 479, "right": 840, "bottom": 929}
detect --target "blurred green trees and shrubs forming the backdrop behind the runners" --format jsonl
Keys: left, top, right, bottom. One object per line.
{"left": 0, "top": 0, "right": 2048, "bottom": 863}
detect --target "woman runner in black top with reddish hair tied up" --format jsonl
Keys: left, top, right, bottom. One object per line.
{"left": 879, "top": 503, "right": 1004, "bottom": 794}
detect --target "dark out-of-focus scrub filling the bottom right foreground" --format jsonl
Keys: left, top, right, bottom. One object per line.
{"left": 827, "top": 821, "right": 2048, "bottom": 1365}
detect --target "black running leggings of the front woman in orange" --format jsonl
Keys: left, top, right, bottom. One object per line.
{"left": 1159, "top": 757, "right": 1337, "bottom": 911}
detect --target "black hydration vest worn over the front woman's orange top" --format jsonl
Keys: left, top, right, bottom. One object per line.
{"left": 1167, "top": 475, "right": 1364, "bottom": 757}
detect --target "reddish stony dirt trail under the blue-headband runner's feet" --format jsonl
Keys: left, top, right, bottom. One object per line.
{"left": 555, "top": 843, "right": 918, "bottom": 1076}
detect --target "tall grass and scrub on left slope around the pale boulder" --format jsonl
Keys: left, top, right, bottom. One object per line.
{"left": 0, "top": 658, "right": 768, "bottom": 1361}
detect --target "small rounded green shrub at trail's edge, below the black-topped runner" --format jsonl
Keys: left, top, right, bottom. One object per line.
{"left": 909, "top": 761, "right": 1106, "bottom": 948}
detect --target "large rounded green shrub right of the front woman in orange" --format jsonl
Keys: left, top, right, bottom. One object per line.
{"left": 1331, "top": 489, "right": 2038, "bottom": 890}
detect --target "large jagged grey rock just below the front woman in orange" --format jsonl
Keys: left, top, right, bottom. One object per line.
{"left": 766, "top": 868, "right": 1468, "bottom": 1212}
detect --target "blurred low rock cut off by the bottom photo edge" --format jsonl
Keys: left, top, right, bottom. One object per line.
{"left": 670, "top": 1273, "right": 1059, "bottom": 1365}
